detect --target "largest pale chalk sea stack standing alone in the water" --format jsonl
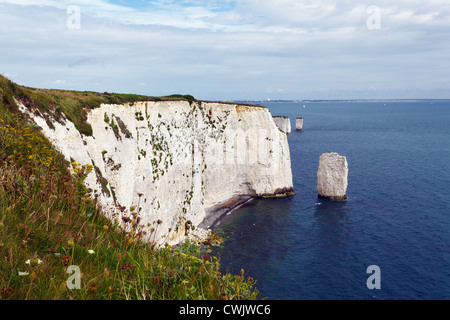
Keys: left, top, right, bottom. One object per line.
{"left": 317, "top": 153, "right": 348, "bottom": 201}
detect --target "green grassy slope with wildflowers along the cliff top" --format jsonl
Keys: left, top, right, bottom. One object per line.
{"left": 0, "top": 76, "right": 258, "bottom": 300}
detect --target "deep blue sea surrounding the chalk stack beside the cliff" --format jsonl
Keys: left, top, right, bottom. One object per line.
{"left": 213, "top": 102, "right": 450, "bottom": 300}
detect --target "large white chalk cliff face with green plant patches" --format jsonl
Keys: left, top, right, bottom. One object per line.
{"left": 19, "top": 101, "right": 293, "bottom": 244}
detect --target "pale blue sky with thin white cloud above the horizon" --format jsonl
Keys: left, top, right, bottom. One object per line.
{"left": 0, "top": 0, "right": 450, "bottom": 100}
